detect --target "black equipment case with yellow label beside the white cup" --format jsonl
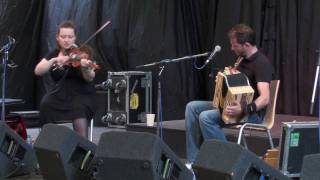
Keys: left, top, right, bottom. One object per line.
{"left": 102, "top": 71, "right": 152, "bottom": 127}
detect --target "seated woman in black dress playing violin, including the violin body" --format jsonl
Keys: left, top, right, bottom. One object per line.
{"left": 34, "top": 21, "right": 95, "bottom": 137}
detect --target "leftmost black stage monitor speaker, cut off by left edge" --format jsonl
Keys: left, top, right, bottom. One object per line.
{"left": 0, "top": 121, "right": 37, "bottom": 179}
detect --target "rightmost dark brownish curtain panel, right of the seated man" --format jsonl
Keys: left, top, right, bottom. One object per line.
{"left": 272, "top": 0, "right": 320, "bottom": 115}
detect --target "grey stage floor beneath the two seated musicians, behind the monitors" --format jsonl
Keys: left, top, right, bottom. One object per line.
{"left": 5, "top": 114, "right": 318, "bottom": 180}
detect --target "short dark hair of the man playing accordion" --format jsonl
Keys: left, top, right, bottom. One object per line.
{"left": 228, "top": 24, "right": 256, "bottom": 46}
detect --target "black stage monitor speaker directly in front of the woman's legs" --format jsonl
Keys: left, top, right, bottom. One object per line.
{"left": 34, "top": 124, "right": 96, "bottom": 180}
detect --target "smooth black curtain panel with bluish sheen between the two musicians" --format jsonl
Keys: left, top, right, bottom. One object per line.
{"left": 41, "top": 0, "right": 205, "bottom": 120}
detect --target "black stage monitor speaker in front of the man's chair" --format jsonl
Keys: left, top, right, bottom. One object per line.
{"left": 192, "top": 140, "right": 289, "bottom": 180}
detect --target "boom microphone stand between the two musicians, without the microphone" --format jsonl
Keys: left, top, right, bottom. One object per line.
{"left": 136, "top": 52, "right": 210, "bottom": 139}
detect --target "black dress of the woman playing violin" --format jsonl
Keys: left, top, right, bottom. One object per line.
{"left": 40, "top": 50, "right": 96, "bottom": 124}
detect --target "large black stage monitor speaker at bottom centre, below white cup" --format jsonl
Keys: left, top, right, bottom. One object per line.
{"left": 95, "top": 131, "right": 193, "bottom": 180}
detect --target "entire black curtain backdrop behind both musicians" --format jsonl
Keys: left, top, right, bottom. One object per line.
{"left": 0, "top": 0, "right": 320, "bottom": 120}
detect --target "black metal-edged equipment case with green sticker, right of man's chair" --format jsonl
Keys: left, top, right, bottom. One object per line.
{"left": 279, "top": 121, "right": 319, "bottom": 177}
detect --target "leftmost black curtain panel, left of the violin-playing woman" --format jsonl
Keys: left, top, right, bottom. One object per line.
{"left": 0, "top": 0, "right": 43, "bottom": 110}
